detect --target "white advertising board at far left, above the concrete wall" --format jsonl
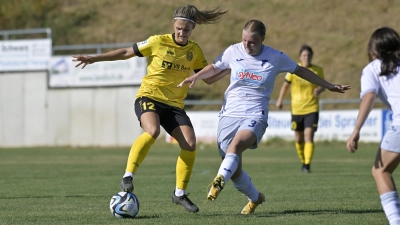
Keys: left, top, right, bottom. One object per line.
{"left": 0, "top": 39, "right": 51, "bottom": 71}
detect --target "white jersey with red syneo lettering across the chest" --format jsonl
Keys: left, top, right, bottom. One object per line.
{"left": 214, "top": 43, "right": 297, "bottom": 119}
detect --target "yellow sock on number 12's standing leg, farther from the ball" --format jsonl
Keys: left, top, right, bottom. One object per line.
{"left": 176, "top": 149, "right": 196, "bottom": 190}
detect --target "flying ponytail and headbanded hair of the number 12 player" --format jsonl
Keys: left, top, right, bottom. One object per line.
{"left": 174, "top": 5, "right": 228, "bottom": 24}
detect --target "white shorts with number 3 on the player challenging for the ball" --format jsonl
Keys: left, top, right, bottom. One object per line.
{"left": 217, "top": 116, "right": 268, "bottom": 157}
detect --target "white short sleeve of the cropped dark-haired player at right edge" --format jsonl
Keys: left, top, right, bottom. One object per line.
{"left": 360, "top": 64, "right": 379, "bottom": 99}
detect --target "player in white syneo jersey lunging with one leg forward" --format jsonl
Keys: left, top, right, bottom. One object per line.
{"left": 178, "top": 20, "right": 350, "bottom": 214}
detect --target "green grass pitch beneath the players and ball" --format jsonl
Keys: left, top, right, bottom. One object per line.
{"left": 0, "top": 140, "right": 387, "bottom": 225}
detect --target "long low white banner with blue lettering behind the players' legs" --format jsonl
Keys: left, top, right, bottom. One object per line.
{"left": 166, "top": 109, "right": 391, "bottom": 143}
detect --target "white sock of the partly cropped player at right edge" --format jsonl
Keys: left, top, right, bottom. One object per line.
{"left": 380, "top": 191, "right": 400, "bottom": 225}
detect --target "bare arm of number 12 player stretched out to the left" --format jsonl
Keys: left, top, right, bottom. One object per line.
{"left": 72, "top": 47, "right": 136, "bottom": 69}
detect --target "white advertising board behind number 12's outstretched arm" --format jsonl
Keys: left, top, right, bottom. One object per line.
{"left": 49, "top": 56, "right": 147, "bottom": 88}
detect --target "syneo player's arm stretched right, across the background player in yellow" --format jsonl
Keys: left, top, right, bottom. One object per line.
{"left": 293, "top": 66, "right": 350, "bottom": 93}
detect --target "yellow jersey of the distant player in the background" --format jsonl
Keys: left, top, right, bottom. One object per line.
{"left": 285, "top": 63, "right": 324, "bottom": 115}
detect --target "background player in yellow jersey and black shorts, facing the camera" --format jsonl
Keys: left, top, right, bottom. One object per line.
{"left": 276, "top": 45, "right": 324, "bottom": 173}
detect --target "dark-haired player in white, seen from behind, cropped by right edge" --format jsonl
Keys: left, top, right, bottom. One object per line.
{"left": 346, "top": 27, "right": 400, "bottom": 225}
